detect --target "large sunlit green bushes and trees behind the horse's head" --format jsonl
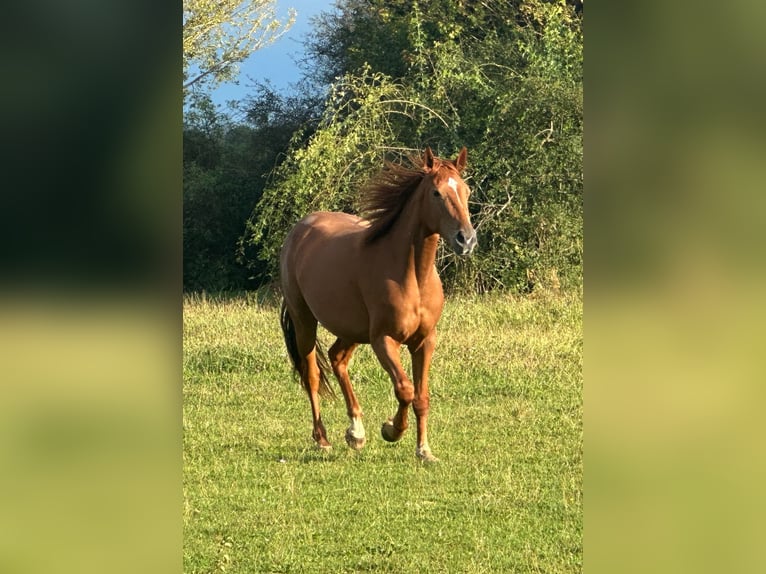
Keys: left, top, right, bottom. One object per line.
{"left": 242, "top": 0, "right": 583, "bottom": 291}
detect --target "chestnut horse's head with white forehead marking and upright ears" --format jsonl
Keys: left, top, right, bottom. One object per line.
{"left": 421, "top": 147, "right": 476, "bottom": 255}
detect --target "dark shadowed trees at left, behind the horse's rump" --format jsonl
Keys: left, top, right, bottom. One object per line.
{"left": 183, "top": 91, "right": 315, "bottom": 291}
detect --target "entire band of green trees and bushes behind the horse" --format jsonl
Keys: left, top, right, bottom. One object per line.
{"left": 184, "top": 0, "right": 583, "bottom": 292}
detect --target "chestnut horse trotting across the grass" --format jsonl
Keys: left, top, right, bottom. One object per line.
{"left": 280, "top": 147, "right": 477, "bottom": 462}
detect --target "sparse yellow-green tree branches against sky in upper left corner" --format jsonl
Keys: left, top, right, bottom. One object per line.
{"left": 183, "top": 0, "right": 295, "bottom": 96}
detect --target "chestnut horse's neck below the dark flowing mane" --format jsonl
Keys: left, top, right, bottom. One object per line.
{"left": 383, "top": 198, "right": 439, "bottom": 286}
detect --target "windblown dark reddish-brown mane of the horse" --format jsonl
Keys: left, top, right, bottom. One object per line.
{"left": 361, "top": 156, "right": 438, "bottom": 243}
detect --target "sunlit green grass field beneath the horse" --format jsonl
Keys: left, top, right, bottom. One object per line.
{"left": 183, "top": 295, "right": 583, "bottom": 573}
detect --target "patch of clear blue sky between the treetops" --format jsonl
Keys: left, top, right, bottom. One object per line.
{"left": 212, "top": 0, "right": 334, "bottom": 105}
